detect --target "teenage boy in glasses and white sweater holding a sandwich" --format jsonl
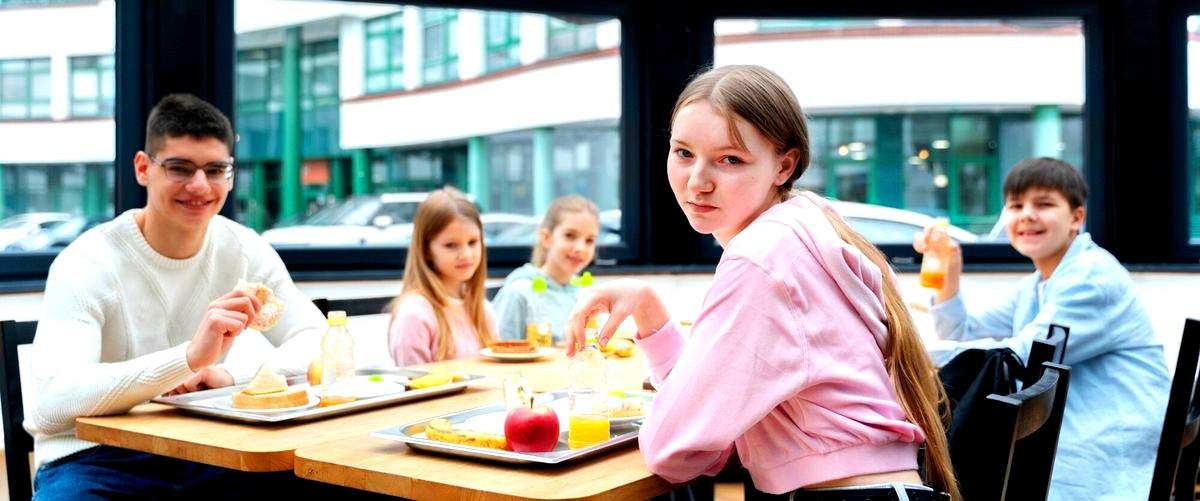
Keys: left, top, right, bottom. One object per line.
{"left": 25, "top": 95, "right": 324, "bottom": 499}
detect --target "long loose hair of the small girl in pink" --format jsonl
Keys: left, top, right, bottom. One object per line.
{"left": 388, "top": 187, "right": 496, "bottom": 361}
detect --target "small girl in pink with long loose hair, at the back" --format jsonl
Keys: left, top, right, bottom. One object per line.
{"left": 388, "top": 187, "right": 496, "bottom": 366}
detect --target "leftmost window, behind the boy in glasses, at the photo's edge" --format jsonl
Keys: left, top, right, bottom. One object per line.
{"left": 0, "top": 0, "right": 115, "bottom": 258}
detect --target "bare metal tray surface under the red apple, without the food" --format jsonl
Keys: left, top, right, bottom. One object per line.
{"left": 371, "top": 392, "right": 641, "bottom": 465}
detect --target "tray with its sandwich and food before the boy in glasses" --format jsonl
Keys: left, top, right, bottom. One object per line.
{"left": 151, "top": 366, "right": 484, "bottom": 423}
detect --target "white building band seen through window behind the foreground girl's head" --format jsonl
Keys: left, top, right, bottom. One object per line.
{"left": 715, "top": 35, "right": 1084, "bottom": 111}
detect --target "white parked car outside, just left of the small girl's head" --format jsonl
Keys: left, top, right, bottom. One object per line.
{"left": 263, "top": 193, "right": 428, "bottom": 247}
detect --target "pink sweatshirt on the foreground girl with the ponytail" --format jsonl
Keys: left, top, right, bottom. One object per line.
{"left": 638, "top": 194, "right": 924, "bottom": 494}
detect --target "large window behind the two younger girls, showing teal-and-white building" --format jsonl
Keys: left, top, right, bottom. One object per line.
{"left": 233, "top": 0, "right": 622, "bottom": 254}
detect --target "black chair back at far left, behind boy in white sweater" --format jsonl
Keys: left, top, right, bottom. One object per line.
{"left": 0, "top": 320, "right": 37, "bottom": 500}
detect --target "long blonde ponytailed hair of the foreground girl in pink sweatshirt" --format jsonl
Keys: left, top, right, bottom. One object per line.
{"left": 671, "top": 66, "right": 961, "bottom": 500}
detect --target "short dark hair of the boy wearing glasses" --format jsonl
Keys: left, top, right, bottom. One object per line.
{"left": 145, "top": 93, "right": 234, "bottom": 156}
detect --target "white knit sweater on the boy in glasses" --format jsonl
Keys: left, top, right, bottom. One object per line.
{"left": 24, "top": 210, "right": 324, "bottom": 465}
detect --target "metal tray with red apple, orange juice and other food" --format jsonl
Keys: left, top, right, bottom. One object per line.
{"left": 372, "top": 391, "right": 654, "bottom": 464}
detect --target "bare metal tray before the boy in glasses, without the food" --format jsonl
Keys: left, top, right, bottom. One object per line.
{"left": 150, "top": 367, "right": 484, "bottom": 423}
